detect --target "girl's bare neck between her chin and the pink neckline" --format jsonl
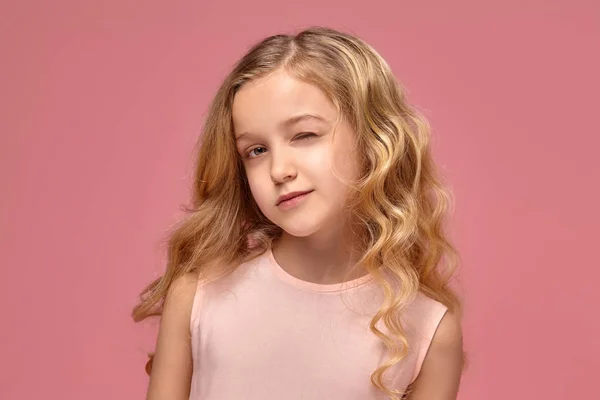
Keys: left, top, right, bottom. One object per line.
{"left": 273, "top": 222, "right": 366, "bottom": 285}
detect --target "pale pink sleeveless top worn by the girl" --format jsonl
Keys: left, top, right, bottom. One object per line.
{"left": 190, "top": 250, "right": 447, "bottom": 400}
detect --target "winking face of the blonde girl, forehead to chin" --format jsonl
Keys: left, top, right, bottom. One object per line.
{"left": 233, "top": 70, "right": 357, "bottom": 237}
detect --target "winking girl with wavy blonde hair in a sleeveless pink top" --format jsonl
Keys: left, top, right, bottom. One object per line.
{"left": 133, "top": 28, "right": 463, "bottom": 400}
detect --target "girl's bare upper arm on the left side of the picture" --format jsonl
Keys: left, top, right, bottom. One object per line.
{"left": 146, "top": 273, "right": 198, "bottom": 400}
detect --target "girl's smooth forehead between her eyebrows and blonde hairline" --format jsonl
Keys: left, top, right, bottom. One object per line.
{"left": 232, "top": 70, "right": 337, "bottom": 134}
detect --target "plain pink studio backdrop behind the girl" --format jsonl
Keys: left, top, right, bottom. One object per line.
{"left": 0, "top": 0, "right": 600, "bottom": 400}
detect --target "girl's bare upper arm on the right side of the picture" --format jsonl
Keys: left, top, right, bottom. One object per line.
{"left": 408, "top": 312, "right": 463, "bottom": 400}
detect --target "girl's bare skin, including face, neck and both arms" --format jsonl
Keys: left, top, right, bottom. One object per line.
{"left": 146, "top": 67, "right": 463, "bottom": 400}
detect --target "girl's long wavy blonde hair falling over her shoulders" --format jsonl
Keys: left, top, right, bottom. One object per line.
{"left": 132, "top": 27, "right": 460, "bottom": 399}
